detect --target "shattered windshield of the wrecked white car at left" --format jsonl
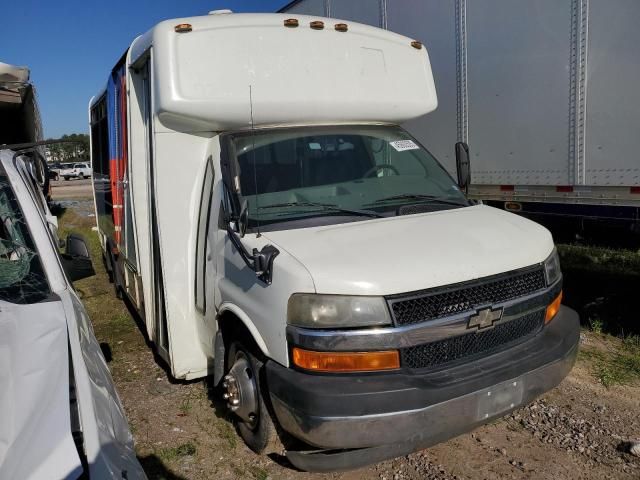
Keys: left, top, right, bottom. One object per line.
{"left": 0, "top": 170, "right": 49, "bottom": 304}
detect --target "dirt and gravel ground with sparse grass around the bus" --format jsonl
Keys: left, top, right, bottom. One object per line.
{"left": 60, "top": 197, "right": 640, "bottom": 480}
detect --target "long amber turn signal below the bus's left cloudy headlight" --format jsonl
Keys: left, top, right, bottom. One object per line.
{"left": 292, "top": 347, "right": 400, "bottom": 372}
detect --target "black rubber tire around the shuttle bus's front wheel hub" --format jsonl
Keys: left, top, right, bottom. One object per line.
{"left": 225, "top": 341, "right": 281, "bottom": 454}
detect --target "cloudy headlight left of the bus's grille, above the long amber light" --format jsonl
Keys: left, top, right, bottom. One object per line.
{"left": 287, "top": 293, "right": 391, "bottom": 328}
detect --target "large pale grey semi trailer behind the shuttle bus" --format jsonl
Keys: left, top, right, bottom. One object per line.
{"left": 281, "top": 0, "right": 640, "bottom": 231}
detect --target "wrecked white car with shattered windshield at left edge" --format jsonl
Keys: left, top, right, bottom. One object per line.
{"left": 0, "top": 150, "right": 146, "bottom": 480}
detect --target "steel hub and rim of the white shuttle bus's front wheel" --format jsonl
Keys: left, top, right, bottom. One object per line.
{"left": 222, "top": 353, "right": 258, "bottom": 425}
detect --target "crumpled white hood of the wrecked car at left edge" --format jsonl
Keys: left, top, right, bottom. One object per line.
{"left": 0, "top": 301, "right": 82, "bottom": 480}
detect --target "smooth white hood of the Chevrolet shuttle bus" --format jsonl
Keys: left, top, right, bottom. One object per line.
{"left": 264, "top": 205, "right": 553, "bottom": 295}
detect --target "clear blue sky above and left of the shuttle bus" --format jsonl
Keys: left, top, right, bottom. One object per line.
{"left": 0, "top": 0, "right": 289, "bottom": 138}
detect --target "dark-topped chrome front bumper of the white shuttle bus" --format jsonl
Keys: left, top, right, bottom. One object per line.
{"left": 267, "top": 307, "right": 580, "bottom": 470}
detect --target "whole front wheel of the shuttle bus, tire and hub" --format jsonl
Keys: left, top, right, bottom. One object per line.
{"left": 222, "top": 341, "right": 278, "bottom": 453}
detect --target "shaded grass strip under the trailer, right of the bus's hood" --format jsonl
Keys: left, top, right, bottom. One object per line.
{"left": 558, "top": 244, "right": 640, "bottom": 275}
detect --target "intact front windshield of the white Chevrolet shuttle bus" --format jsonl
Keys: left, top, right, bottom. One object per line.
{"left": 228, "top": 126, "right": 469, "bottom": 229}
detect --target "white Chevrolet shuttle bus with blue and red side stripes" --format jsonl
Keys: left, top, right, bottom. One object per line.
{"left": 90, "top": 13, "right": 579, "bottom": 471}
